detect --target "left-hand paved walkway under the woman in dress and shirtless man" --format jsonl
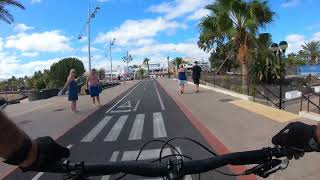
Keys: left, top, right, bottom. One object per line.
{"left": 0, "top": 81, "right": 138, "bottom": 179}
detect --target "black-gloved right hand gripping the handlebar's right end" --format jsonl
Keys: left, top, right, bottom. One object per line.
{"left": 272, "top": 122, "right": 320, "bottom": 155}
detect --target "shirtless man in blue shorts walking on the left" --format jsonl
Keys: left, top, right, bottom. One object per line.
{"left": 86, "top": 69, "right": 100, "bottom": 105}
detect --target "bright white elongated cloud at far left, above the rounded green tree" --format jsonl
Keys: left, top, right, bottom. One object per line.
{"left": 5, "top": 31, "right": 72, "bottom": 52}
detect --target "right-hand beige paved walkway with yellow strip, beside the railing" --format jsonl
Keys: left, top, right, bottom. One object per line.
{"left": 158, "top": 79, "right": 320, "bottom": 180}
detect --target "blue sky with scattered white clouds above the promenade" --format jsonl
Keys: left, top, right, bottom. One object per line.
{"left": 0, "top": 0, "right": 320, "bottom": 79}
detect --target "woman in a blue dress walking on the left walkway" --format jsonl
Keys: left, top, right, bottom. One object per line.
{"left": 63, "top": 69, "right": 78, "bottom": 113}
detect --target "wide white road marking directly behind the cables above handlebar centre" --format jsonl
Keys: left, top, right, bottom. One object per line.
{"left": 121, "top": 148, "right": 172, "bottom": 161}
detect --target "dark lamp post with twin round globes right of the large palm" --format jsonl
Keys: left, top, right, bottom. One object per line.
{"left": 270, "top": 41, "right": 288, "bottom": 109}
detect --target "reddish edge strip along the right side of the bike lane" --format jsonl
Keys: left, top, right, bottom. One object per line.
{"left": 158, "top": 81, "right": 257, "bottom": 180}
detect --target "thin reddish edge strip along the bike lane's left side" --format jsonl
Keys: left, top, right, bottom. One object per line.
{"left": 0, "top": 82, "right": 138, "bottom": 179}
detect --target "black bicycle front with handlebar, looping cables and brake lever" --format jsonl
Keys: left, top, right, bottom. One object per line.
{"left": 24, "top": 137, "right": 301, "bottom": 180}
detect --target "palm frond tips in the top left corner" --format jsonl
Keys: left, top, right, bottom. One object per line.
{"left": 0, "top": 0, "right": 25, "bottom": 24}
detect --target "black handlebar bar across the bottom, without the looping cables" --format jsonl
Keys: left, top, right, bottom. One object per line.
{"left": 26, "top": 146, "right": 297, "bottom": 179}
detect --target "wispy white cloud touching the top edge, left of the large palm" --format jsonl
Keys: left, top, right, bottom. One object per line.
{"left": 149, "top": 0, "right": 214, "bottom": 19}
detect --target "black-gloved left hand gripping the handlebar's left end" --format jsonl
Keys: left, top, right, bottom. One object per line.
{"left": 21, "top": 136, "right": 70, "bottom": 171}
